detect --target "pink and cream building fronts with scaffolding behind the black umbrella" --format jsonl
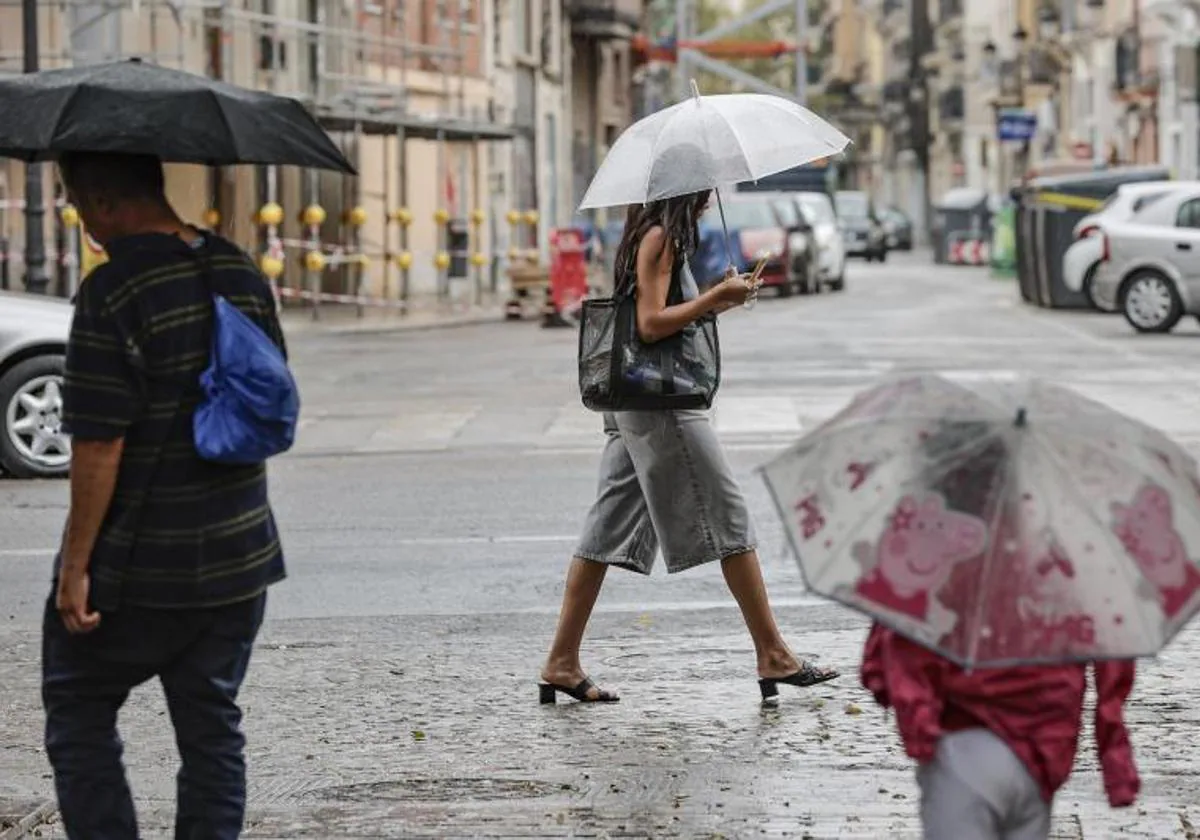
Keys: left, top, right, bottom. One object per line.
{"left": 0, "top": 0, "right": 586, "bottom": 309}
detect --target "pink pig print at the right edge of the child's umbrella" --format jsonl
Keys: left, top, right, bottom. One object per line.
{"left": 1112, "top": 484, "right": 1200, "bottom": 618}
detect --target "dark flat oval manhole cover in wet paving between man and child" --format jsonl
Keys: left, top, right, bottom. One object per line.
{"left": 299, "top": 778, "right": 570, "bottom": 803}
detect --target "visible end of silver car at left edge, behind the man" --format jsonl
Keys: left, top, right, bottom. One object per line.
{"left": 0, "top": 292, "right": 73, "bottom": 479}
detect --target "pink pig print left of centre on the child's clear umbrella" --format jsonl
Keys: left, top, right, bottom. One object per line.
{"left": 854, "top": 494, "right": 988, "bottom": 622}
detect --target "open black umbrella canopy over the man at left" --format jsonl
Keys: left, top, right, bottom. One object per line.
{"left": 0, "top": 59, "right": 355, "bottom": 175}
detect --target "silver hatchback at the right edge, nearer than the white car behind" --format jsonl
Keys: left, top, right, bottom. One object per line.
{"left": 1092, "top": 184, "right": 1200, "bottom": 332}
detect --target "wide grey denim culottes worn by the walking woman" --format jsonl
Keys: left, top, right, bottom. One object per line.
{"left": 575, "top": 410, "right": 755, "bottom": 575}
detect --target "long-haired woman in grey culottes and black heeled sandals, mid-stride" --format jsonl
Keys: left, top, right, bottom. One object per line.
{"left": 541, "top": 191, "right": 839, "bottom": 703}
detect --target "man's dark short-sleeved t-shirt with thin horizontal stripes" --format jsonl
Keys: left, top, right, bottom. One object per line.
{"left": 64, "top": 234, "right": 284, "bottom": 611}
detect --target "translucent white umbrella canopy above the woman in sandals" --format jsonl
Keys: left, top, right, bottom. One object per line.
{"left": 580, "top": 94, "right": 850, "bottom": 210}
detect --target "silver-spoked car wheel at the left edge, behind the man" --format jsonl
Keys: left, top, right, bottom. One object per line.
{"left": 0, "top": 355, "right": 71, "bottom": 479}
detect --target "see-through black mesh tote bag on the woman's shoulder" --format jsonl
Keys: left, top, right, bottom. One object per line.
{"left": 578, "top": 255, "right": 721, "bottom": 412}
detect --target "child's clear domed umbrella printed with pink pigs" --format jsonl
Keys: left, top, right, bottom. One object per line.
{"left": 762, "top": 374, "right": 1200, "bottom": 667}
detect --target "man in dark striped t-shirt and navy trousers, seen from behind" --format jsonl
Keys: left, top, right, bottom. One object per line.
{"left": 42, "top": 154, "right": 284, "bottom": 840}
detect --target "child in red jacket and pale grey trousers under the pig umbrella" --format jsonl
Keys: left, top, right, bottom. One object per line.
{"left": 862, "top": 624, "right": 1140, "bottom": 840}
